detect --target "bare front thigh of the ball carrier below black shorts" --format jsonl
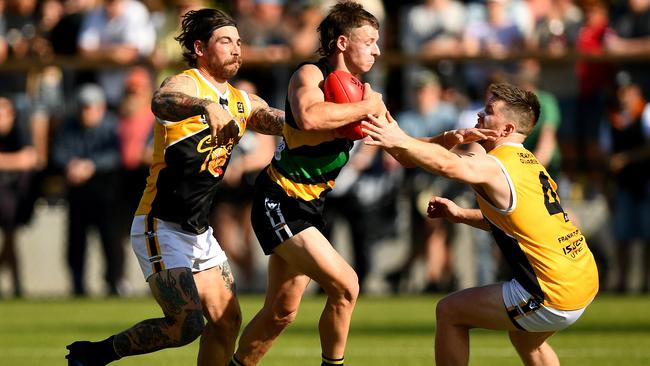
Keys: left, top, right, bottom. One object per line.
{"left": 274, "top": 227, "right": 358, "bottom": 291}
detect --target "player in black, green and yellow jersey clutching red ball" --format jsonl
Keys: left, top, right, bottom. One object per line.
{"left": 231, "top": 1, "right": 385, "bottom": 365}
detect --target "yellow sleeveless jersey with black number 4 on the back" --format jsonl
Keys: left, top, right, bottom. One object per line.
{"left": 476, "top": 143, "right": 598, "bottom": 310}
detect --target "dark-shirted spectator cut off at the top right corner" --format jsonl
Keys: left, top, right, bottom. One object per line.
{"left": 605, "top": 0, "right": 650, "bottom": 98}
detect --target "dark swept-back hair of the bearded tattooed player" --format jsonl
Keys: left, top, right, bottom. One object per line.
{"left": 174, "top": 8, "right": 237, "bottom": 67}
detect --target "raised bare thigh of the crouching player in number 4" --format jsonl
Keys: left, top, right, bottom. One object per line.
{"left": 436, "top": 284, "right": 517, "bottom": 330}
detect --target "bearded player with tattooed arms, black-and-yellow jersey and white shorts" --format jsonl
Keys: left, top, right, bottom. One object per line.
{"left": 66, "top": 9, "right": 284, "bottom": 366}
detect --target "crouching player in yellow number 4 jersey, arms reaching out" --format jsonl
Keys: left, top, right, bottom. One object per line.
{"left": 363, "top": 84, "right": 598, "bottom": 366}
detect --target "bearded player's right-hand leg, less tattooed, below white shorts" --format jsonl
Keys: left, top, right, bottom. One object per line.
{"left": 194, "top": 262, "right": 241, "bottom": 366}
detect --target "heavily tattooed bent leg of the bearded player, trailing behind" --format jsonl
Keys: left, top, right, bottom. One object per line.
{"left": 114, "top": 268, "right": 204, "bottom": 356}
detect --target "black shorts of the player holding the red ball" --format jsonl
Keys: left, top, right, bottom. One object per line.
{"left": 251, "top": 171, "right": 325, "bottom": 255}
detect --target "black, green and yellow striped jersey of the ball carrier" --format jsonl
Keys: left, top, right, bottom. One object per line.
{"left": 266, "top": 59, "right": 353, "bottom": 206}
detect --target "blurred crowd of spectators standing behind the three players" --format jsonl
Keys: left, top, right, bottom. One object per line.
{"left": 0, "top": 0, "right": 650, "bottom": 296}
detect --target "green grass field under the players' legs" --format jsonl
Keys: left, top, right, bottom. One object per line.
{"left": 0, "top": 295, "right": 650, "bottom": 366}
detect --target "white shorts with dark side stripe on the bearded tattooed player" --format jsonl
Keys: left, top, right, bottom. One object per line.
{"left": 131, "top": 215, "right": 228, "bottom": 280}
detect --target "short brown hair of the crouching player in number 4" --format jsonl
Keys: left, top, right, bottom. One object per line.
{"left": 489, "top": 83, "right": 540, "bottom": 135}
